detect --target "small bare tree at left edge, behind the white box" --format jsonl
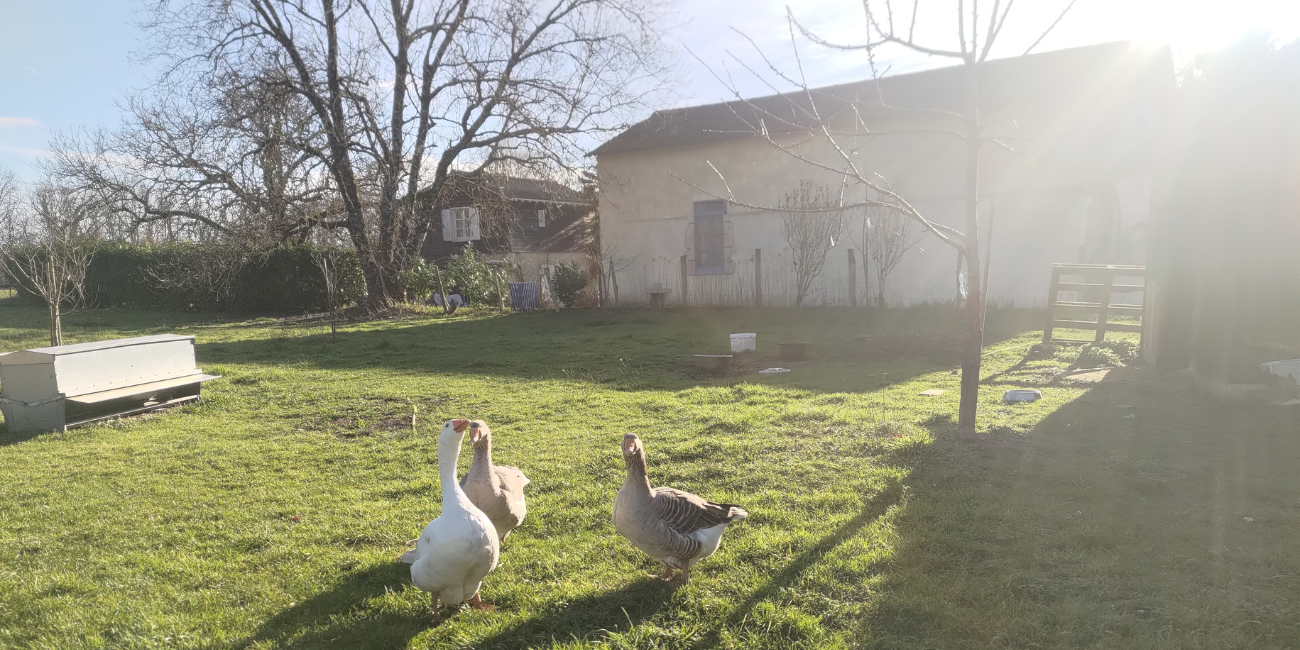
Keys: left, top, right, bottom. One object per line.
{"left": 0, "top": 182, "right": 100, "bottom": 346}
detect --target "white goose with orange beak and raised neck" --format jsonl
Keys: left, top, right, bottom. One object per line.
{"left": 402, "top": 420, "right": 501, "bottom": 620}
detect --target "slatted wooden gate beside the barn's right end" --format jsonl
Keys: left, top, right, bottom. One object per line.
{"left": 1043, "top": 264, "right": 1147, "bottom": 345}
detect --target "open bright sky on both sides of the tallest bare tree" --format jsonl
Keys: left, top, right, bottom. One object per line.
{"left": 0, "top": 0, "right": 1300, "bottom": 181}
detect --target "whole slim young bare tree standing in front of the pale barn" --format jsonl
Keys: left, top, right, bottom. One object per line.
{"left": 684, "top": 0, "right": 1074, "bottom": 434}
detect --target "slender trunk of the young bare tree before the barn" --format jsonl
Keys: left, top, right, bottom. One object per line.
{"left": 957, "top": 61, "right": 984, "bottom": 436}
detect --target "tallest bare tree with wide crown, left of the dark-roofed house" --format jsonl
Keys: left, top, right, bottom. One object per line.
{"left": 142, "top": 0, "right": 663, "bottom": 309}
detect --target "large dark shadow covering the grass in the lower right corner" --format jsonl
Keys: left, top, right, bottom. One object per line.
{"left": 858, "top": 369, "right": 1300, "bottom": 649}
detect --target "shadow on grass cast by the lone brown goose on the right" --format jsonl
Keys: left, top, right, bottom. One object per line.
{"left": 475, "top": 579, "right": 675, "bottom": 650}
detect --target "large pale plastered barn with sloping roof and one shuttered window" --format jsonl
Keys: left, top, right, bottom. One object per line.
{"left": 593, "top": 43, "right": 1174, "bottom": 307}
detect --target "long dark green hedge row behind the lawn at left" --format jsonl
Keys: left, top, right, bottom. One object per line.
{"left": 49, "top": 243, "right": 365, "bottom": 313}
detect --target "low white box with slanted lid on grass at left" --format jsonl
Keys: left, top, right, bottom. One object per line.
{"left": 0, "top": 334, "right": 217, "bottom": 432}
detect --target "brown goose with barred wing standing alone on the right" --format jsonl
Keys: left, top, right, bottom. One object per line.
{"left": 614, "top": 433, "right": 749, "bottom": 582}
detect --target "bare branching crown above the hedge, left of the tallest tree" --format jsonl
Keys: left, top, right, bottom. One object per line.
{"left": 43, "top": 69, "right": 341, "bottom": 247}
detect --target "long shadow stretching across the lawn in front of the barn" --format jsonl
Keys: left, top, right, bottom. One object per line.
{"left": 199, "top": 309, "right": 1045, "bottom": 393}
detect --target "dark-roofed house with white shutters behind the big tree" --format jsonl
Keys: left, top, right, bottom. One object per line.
{"left": 421, "top": 176, "right": 595, "bottom": 287}
